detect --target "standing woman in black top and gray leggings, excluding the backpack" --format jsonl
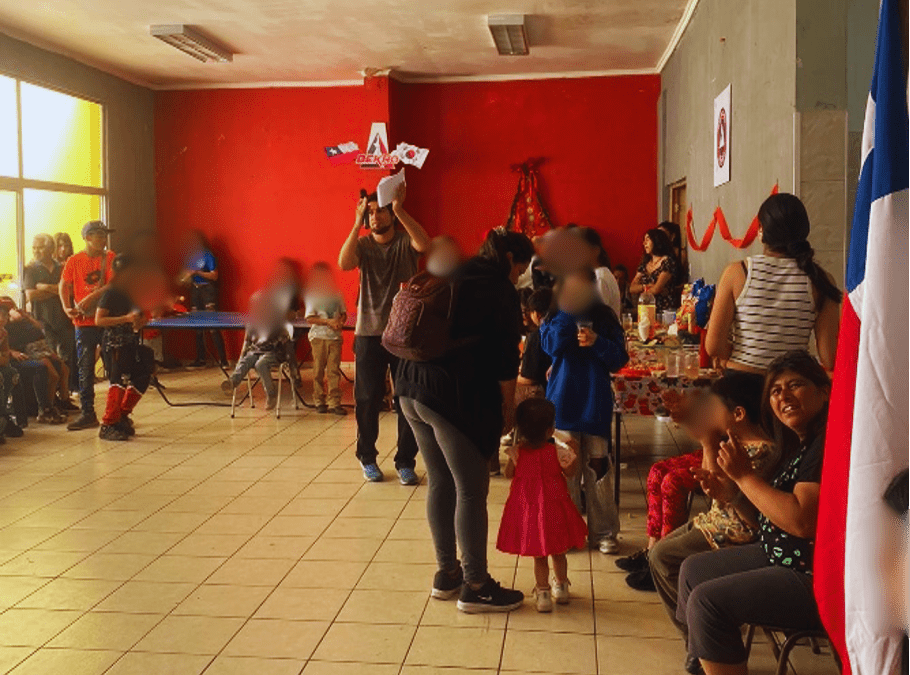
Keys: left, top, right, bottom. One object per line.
{"left": 395, "top": 228, "right": 534, "bottom": 613}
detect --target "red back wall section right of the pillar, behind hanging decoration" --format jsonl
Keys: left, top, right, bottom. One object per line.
{"left": 391, "top": 75, "right": 660, "bottom": 274}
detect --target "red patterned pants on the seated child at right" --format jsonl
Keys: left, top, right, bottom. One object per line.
{"left": 648, "top": 449, "right": 702, "bottom": 539}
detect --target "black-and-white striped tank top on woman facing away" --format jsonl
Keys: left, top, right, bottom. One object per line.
{"left": 730, "top": 255, "right": 816, "bottom": 369}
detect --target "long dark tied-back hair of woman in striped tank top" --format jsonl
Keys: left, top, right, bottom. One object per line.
{"left": 758, "top": 192, "right": 843, "bottom": 309}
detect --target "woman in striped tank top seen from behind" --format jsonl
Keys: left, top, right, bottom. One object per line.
{"left": 705, "top": 193, "right": 842, "bottom": 374}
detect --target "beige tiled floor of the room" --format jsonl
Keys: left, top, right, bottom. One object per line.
{"left": 0, "top": 370, "right": 835, "bottom": 675}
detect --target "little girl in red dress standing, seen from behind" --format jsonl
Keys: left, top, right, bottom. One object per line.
{"left": 496, "top": 398, "right": 588, "bottom": 612}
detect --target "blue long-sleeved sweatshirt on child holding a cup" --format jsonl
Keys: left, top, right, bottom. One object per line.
{"left": 540, "top": 305, "right": 629, "bottom": 436}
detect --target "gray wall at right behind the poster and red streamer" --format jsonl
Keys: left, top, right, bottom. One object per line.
{"left": 659, "top": 0, "right": 796, "bottom": 282}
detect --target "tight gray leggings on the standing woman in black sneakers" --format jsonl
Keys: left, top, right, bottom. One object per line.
{"left": 400, "top": 397, "right": 490, "bottom": 584}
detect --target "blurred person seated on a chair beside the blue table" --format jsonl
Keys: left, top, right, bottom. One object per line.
{"left": 221, "top": 291, "right": 290, "bottom": 410}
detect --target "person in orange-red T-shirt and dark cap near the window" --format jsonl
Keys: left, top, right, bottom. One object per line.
{"left": 60, "top": 220, "right": 114, "bottom": 431}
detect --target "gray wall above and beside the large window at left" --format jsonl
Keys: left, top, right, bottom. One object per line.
{"left": 0, "top": 33, "right": 155, "bottom": 248}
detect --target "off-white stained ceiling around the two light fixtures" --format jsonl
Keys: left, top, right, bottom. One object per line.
{"left": 0, "top": 0, "right": 695, "bottom": 87}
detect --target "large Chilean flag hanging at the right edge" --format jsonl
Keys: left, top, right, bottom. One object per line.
{"left": 815, "top": 0, "right": 910, "bottom": 675}
